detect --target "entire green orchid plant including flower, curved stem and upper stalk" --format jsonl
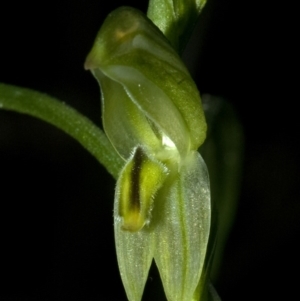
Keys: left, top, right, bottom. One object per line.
{"left": 0, "top": 1, "right": 243, "bottom": 300}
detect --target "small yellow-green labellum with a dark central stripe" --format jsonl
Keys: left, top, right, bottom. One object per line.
{"left": 116, "top": 146, "right": 168, "bottom": 231}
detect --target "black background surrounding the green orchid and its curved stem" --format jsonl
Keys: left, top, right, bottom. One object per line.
{"left": 0, "top": 0, "right": 300, "bottom": 301}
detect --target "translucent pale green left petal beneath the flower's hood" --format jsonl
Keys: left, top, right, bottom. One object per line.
{"left": 93, "top": 69, "right": 161, "bottom": 160}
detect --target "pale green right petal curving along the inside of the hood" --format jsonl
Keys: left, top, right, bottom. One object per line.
{"left": 104, "top": 66, "right": 190, "bottom": 157}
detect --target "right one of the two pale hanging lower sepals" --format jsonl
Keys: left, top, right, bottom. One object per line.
{"left": 153, "top": 152, "right": 211, "bottom": 301}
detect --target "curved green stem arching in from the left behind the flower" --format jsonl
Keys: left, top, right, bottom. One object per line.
{"left": 0, "top": 83, "right": 124, "bottom": 178}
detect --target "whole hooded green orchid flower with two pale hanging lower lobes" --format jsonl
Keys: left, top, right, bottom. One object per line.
{"left": 85, "top": 7, "right": 211, "bottom": 301}
